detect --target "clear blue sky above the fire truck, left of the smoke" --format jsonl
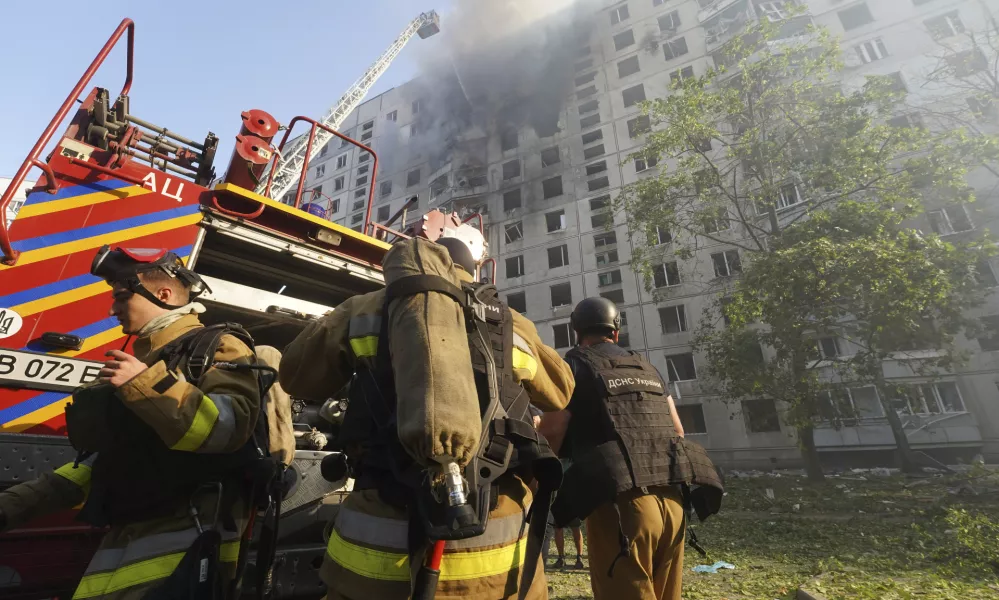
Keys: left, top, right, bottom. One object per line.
{"left": 0, "top": 0, "right": 451, "bottom": 179}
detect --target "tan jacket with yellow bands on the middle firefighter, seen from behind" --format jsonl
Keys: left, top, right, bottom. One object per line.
{"left": 279, "top": 238, "right": 574, "bottom": 600}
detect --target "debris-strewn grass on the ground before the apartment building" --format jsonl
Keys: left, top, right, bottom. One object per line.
{"left": 549, "top": 469, "right": 999, "bottom": 600}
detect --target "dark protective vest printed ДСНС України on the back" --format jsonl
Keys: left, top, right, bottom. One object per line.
{"left": 552, "top": 347, "right": 723, "bottom": 525}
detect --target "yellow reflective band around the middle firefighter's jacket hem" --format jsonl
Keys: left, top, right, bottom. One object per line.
{"left": 326, "top": 530, "right": 527, "bottom": 581}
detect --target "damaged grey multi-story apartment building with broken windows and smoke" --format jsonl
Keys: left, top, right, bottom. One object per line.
{"left": 296, "top": 0, "right": 999, "bottom": 466}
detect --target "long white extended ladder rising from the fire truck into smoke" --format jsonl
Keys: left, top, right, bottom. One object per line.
{"left": 256, "top": 11, "right": 440, "bottom": 199}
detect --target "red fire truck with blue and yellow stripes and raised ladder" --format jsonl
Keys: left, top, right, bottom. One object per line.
{"left": 0, "top": 12, "right": 482, "bottom": 600}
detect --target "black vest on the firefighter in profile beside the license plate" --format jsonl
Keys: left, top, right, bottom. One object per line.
{"left": 66, "top": 324, "right": 278, "bottom": 526}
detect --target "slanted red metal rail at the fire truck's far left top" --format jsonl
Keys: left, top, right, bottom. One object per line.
{"left": 0, "top": 19, "right": 135, "bottom": 266}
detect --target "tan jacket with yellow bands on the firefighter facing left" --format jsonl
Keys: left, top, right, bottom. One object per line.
{"left": 0, "top": 314, "right": 260, "bottom": 600}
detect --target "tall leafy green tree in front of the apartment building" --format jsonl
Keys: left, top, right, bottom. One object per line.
{"left": 617, "top": 15, "right": 996, "bottom": 478}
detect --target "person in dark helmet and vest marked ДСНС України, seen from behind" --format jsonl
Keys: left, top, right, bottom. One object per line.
{"left": 540, "top": 297, "right": 721, "bottom": 600}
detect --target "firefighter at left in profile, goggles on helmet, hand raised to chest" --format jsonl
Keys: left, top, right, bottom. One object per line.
{"left": 0, "top": 246, "right": 260, "bottom": 599}
